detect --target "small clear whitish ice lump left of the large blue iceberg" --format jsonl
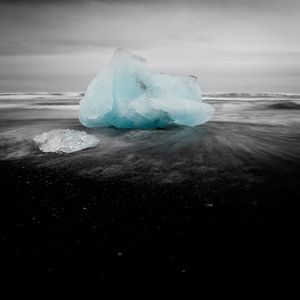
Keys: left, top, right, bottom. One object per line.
{"left": 33, "top": 129, "right": 99, "bottom": 153}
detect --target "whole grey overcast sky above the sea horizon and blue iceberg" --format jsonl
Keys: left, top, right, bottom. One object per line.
{"left": 0, "top": 0, "right": 300, "bottom": 92}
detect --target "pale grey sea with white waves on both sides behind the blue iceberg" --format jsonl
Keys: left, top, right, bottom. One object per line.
{"left": 0, "top": 92, "right": 300, "bottom": 125}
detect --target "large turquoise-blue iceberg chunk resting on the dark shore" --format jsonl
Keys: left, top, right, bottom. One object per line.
{"left": 79, "top": 49, "right": 214, "bottom": 129}
